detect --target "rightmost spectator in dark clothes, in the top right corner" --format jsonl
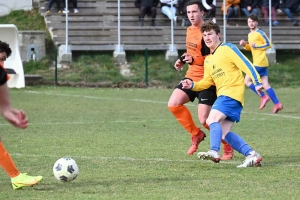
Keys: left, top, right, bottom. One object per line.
{"left": 281, "top": 0, "right": 300, "bottom": 26}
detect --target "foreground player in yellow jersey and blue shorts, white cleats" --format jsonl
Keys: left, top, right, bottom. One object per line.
{"left": 181, "top": 21, "right": 263, "bottom": 168}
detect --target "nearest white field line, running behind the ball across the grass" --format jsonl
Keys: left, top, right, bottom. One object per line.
{"left": 10, "top": 153, "right": 300, "bottom": 167}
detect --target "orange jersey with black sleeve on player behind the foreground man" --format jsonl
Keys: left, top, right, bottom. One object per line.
{"left": 185, "top": 26, "right": 210, "bottom": 82}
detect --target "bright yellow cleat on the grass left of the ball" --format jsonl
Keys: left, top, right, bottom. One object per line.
{"left": 11, "top": 173, "right": 43, "bottom": 190}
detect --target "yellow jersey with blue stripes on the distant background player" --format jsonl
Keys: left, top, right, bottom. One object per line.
{"left": 244, "top": 29, "right": 272, "bottom": 67}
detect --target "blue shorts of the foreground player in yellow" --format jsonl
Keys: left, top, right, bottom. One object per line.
{"left": 211, "top": 96, "right": 243, "bottom": 122}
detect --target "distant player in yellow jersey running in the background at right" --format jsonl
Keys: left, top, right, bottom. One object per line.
{"left": 240, "top": 15, "right": 283, "bottom": 113}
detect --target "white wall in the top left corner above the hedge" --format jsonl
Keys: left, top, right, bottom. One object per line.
{"left": 0, "top": 0, "right": 32, "bottom": 16}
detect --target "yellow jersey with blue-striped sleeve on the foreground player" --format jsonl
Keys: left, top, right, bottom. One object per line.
{"left": 192, "top": 43, "right": 261, "bottom": 105}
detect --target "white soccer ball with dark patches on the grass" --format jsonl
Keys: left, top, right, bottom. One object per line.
{"left": 53, "top": 157, "right": 79, "bottom": 182}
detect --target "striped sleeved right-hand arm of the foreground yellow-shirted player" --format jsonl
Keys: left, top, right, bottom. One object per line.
{"left": 228, "top": 45, "right": 262, "bottom": 86}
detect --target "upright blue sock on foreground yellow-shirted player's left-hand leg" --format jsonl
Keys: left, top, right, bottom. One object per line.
{"left": 209, "top": 122, "right": 222, "bottom": 152}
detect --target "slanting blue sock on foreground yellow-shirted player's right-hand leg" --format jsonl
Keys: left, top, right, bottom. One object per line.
{"left": 224, "top": 132, "right": 253, "bottom": 156}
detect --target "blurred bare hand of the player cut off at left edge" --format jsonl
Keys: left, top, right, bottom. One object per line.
{"left": 2, "top": 108, "right": 28, "bottom": 128}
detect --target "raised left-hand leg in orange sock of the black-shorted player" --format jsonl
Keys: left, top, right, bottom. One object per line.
{"left": 168, "top": 79, "right": 205, "bottom": 155}
